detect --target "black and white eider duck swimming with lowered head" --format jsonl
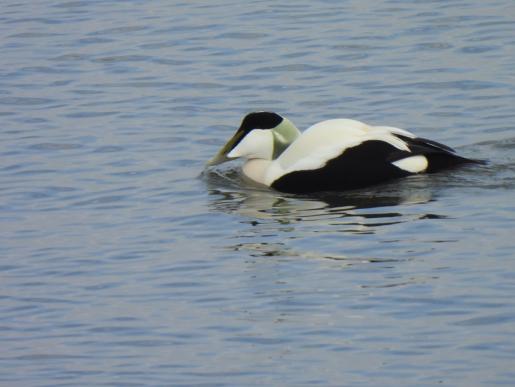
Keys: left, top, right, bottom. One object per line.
{"left": 207, "top": 111, "right": 481, "bottom": 193}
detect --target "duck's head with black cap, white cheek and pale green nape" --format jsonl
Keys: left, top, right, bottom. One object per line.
{"left": 207, "top": 112, "right": 300, "bottom": 166}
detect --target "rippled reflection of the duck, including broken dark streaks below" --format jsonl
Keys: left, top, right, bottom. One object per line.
{"left": 203, "top": 169, "right": 445, "bottom": 265}
